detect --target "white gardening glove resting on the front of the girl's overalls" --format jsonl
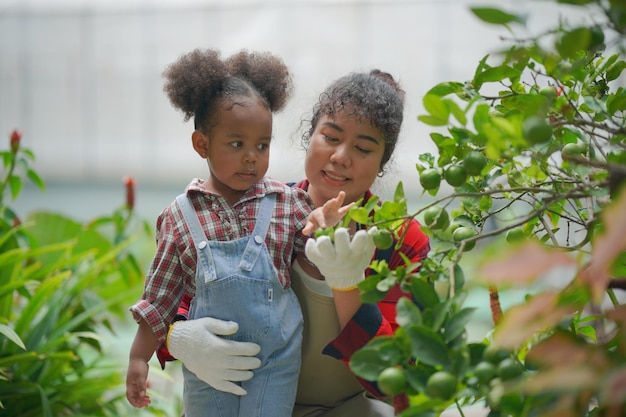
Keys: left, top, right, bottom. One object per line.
{"left": 167, "top": 317, "right": 261, "bottom": 395}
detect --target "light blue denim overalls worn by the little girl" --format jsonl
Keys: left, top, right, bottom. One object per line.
{"left": 176, "top": 194, "right": 302, "bottom": 417}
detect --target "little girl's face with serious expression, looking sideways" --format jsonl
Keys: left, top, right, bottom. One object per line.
{"left": 192, "top": 97, "right": 272, "bottom": 204}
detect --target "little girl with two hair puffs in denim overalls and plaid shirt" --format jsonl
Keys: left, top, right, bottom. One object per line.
{"left": 126, "top": 50, "right": 340, "bottom": 417}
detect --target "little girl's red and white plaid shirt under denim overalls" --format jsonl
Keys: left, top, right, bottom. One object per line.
{"left": 130, "top": 177, "right": 315, "bottom": 342}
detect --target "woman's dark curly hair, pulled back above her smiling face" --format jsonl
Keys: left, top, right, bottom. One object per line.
{"left": 303, "top": 69, "right": 405, "bottom": 170}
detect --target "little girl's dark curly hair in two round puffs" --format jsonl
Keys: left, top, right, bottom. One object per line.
{"left": 163, "top": 49, "right": 293, "bottom": 130}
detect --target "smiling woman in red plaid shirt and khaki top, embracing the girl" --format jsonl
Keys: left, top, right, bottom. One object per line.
{"left": 159, "top": 70, "right": 430, "bottom": 417}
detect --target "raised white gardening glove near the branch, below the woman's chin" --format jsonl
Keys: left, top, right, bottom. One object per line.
{"left": 304, "top": 226, "right": 378, "bottom": 291}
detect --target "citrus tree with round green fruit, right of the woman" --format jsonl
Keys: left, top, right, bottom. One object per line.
{"left": 342, "top": 0, "right": 626, "bottom": 417}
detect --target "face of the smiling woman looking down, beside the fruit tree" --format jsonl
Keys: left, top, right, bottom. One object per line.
{"left": 304, "top": 112, "right": 385, "bottom": 207}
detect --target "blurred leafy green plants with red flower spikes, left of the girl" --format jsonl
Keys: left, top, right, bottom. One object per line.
{"left": 0, "top": 131, "right": 173, "bottom": 417}
